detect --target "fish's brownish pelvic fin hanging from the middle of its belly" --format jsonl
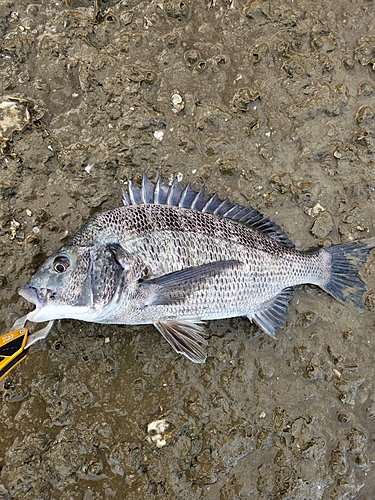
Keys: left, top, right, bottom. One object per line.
{"left": 154, "top": 320, "right": 207, "bottom": 363}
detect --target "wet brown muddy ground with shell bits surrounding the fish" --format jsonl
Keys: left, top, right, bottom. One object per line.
{"left": 0, "top": 0, "right": 375, "bottom": 500}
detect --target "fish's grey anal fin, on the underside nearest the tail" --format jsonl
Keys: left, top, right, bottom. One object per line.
{"left": 248, "top": 287, "right": 293, "bottom": 339}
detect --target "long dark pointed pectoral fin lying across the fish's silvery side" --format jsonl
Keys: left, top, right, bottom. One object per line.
{"left": 139, "top": 260, "right": 242, "bottom": 306}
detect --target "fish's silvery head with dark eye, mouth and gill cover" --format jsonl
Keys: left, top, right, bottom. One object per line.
{"left": 19, "top": 240, "right": 126, "bottom": 322}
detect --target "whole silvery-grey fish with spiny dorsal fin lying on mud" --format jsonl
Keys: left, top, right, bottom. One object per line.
{"left": 19, "top": 174, "right": 371, "bottom": 363}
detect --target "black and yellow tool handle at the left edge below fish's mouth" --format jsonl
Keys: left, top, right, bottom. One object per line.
{"left": 0, "top": 328, "right": 28, "bottom": 380}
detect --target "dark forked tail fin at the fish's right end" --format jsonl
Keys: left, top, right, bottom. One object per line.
{"left": 320, "top": 242, "right": 373, "bottom": 309}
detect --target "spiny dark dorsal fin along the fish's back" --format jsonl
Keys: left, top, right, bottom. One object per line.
{"left": 122, "top": 173, "right": 294, "bottom": 248}
